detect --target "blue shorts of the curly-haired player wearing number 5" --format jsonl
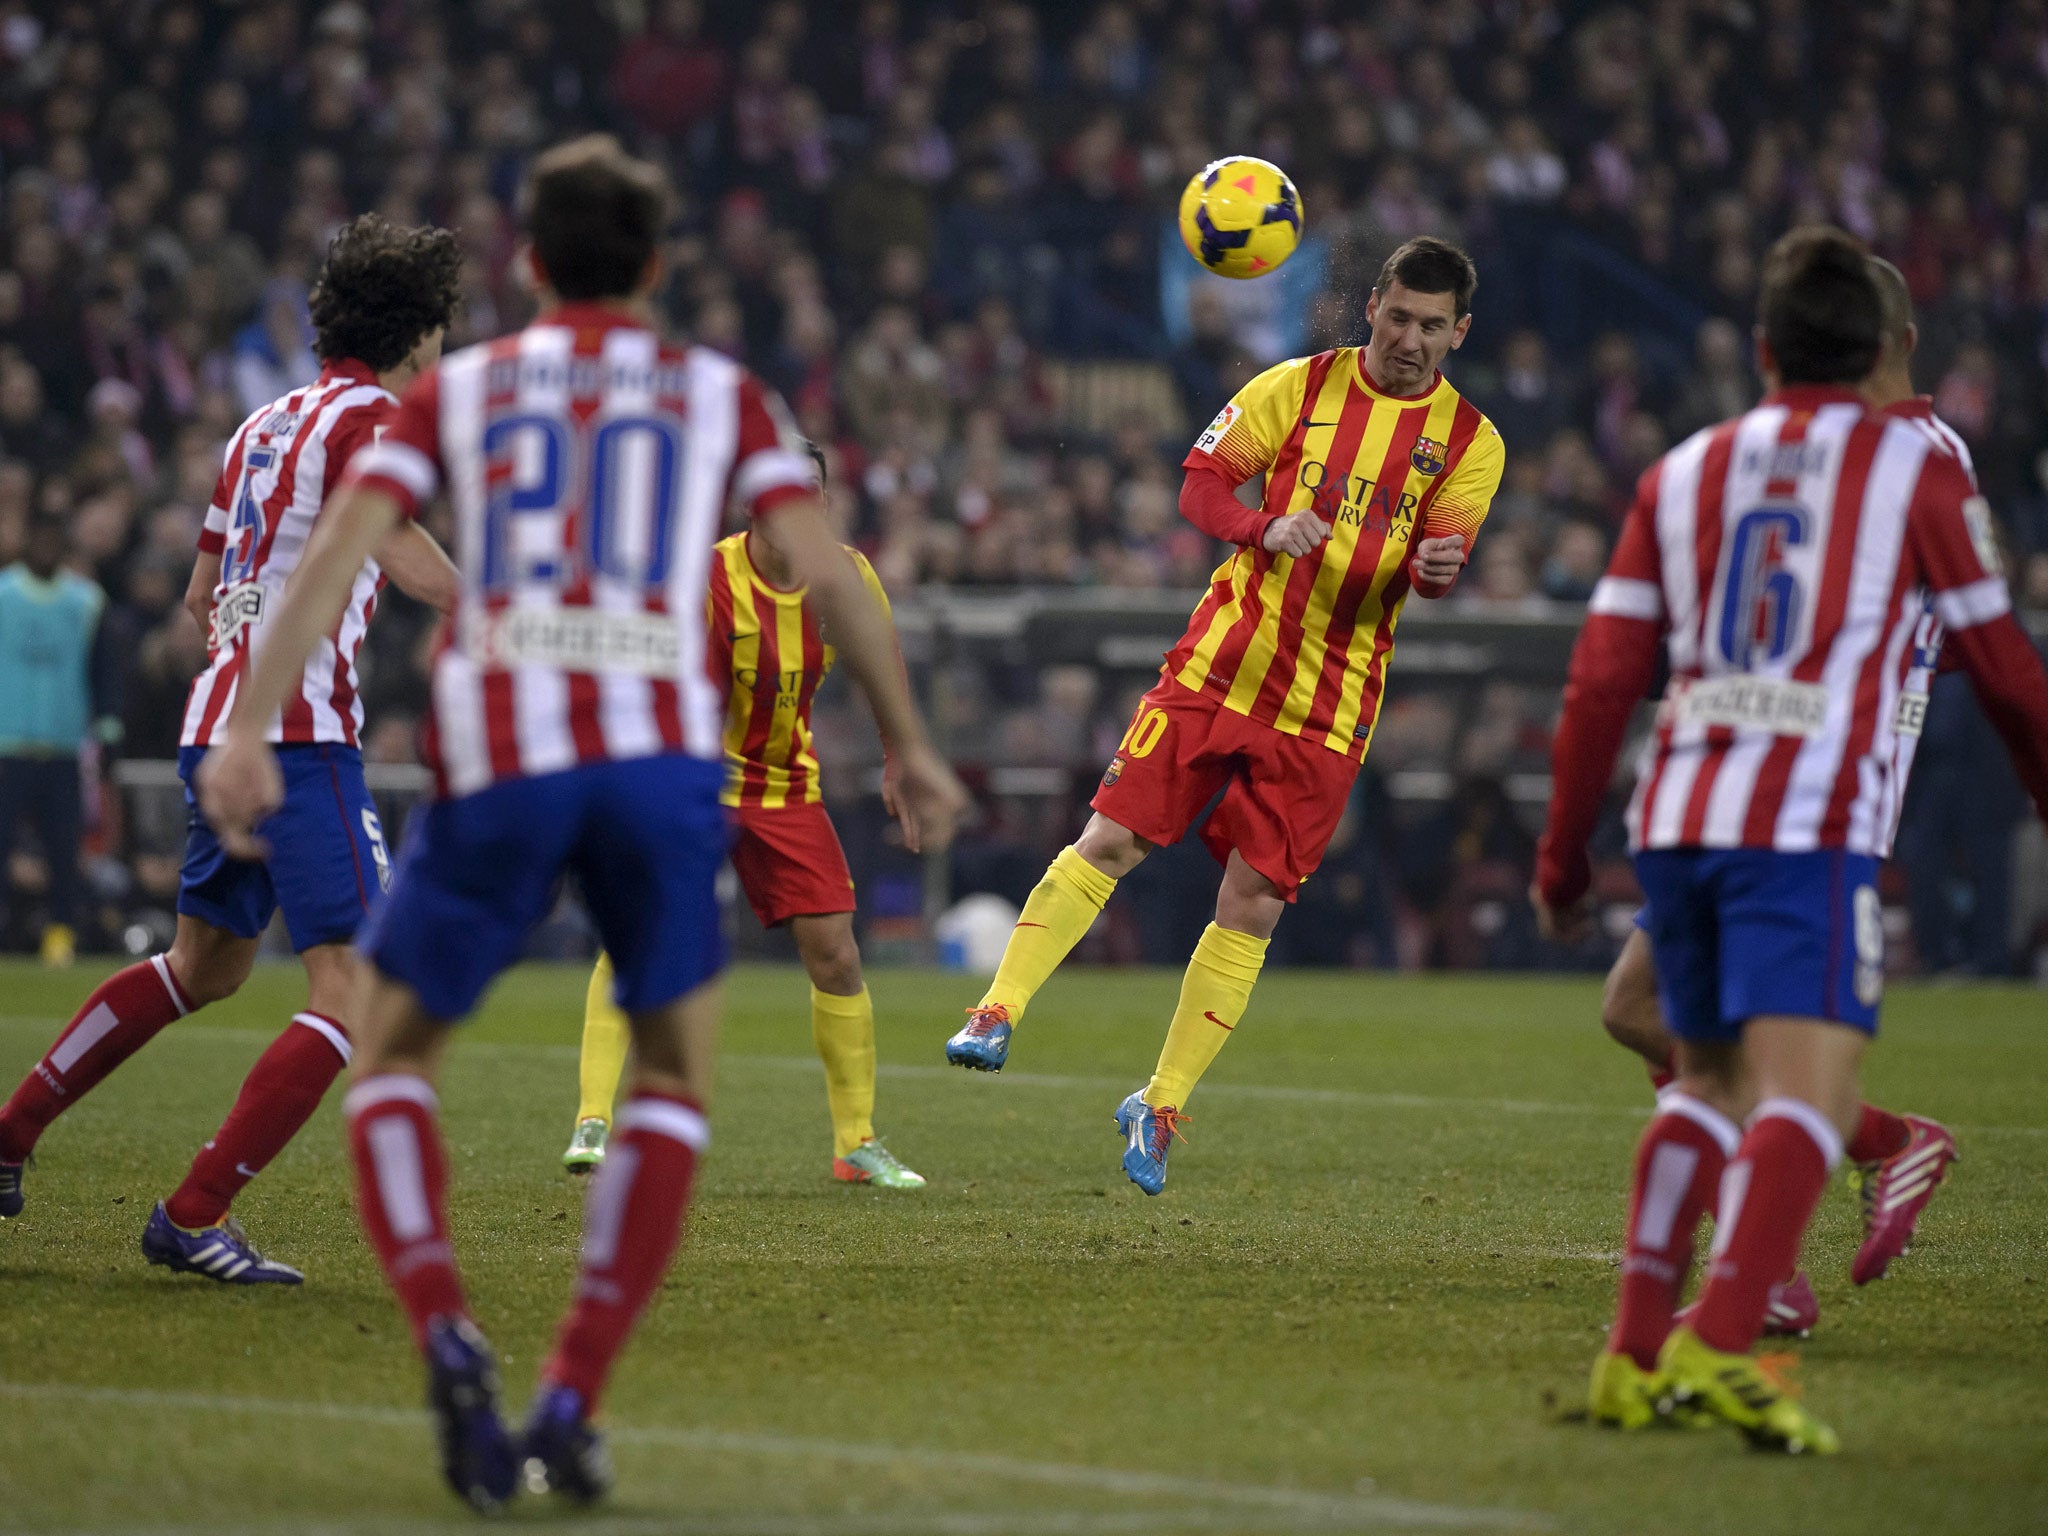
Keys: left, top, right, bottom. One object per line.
{"left": 178, "top": 741, "right": 391, "bottom": 950}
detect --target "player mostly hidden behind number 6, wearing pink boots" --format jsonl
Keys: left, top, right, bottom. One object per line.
{"left": 1599, "top": 256, "right": 1976, "bottom": 1354}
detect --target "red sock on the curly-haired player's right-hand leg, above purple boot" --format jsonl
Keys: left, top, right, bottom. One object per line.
{"left": 164, "top": 1014, "right": 350, "bottom": 1231}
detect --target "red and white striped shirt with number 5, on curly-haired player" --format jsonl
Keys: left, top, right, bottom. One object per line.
{"left": 178, "top": 360, "right": 397, "bottom": 748}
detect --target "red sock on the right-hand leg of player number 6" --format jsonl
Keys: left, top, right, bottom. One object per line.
{"left": 1692, "top": 1098, "right": 1841, "bottom": 1354}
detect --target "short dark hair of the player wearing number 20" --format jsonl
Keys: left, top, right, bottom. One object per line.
{"left": 526, "top": 133, "right": 668, "bottom": 299}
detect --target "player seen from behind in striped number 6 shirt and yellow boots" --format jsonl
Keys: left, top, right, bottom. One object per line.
{"left": 1536, "top": 229, "right": 2048, "bottom": 1452}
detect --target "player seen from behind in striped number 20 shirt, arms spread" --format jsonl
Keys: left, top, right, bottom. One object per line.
{"left": 199, "top": 137, "right": 965, "bottom": 1509}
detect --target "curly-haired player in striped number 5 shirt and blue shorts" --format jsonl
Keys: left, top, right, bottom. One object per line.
{"left": 0, "top": 213, "right": 461, "bottom": 1286}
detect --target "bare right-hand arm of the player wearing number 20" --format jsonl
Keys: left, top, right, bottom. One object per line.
{"left": 756, "top": 496, "right": 967, "bottom": 848}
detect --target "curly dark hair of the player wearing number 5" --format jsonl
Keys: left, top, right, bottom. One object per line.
{"left": 309, "top": 213, "right": 463, "bottom": 373}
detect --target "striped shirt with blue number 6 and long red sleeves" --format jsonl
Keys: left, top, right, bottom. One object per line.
{"left": 1538, "top": 387, "right": 2048, "bottom": 905}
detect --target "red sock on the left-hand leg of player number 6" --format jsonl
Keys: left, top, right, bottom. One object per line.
{"left": 1608, "top": 1092, "right": 1741, "bottom": 1370}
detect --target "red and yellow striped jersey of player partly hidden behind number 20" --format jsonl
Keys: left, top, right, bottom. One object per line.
{"left": 709, "top": 532, "right": 889, "bottom": 811}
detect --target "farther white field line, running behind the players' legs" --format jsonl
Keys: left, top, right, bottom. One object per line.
{"left": 0, "top": 1014, "right": 2048, "bottom": 1137}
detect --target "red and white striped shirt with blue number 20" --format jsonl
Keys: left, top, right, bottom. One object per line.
{"left": 352, "top": 303, "right": 817, "bottom": 795}
